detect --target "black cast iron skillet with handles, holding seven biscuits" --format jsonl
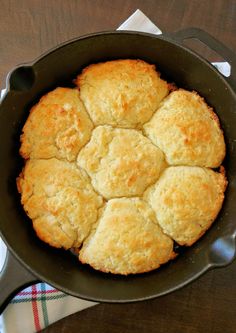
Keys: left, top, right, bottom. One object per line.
{"left": 0, "top": 29, "right": 236, "bottom": 310}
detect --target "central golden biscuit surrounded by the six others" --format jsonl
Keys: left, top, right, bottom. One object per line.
{"left": 77, "top": 126, "right": 165, "bottom": 199}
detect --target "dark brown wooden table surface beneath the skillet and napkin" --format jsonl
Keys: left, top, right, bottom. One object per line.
{"left": 0, "top": 0, "right": 236, "bottom": 333}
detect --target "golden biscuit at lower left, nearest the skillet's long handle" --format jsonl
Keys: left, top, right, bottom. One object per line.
{"left": 17, "top": 158, "right": 103, "bottom": 249}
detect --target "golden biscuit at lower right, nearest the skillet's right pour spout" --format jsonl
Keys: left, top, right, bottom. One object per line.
{"left": 144, "top": 166, "right": 227, "bottom": 245}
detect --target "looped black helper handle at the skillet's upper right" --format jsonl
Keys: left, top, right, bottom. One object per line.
{"left": 165, "top": 28, "right": 236, "bottom": 92}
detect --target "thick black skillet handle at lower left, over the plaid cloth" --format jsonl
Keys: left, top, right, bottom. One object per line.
{"left": 0, "top": 251, "right": 39, "bottom": 314}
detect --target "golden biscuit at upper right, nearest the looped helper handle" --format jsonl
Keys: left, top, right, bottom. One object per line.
{"left": 144, "top": 89, "right": 225, "bottom": 168}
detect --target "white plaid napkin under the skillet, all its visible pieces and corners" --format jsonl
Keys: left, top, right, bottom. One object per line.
{"left": 0, "top": 9, "right": 230, "bottom": 333}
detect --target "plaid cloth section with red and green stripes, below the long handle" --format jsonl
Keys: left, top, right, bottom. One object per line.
{"left": 2, "top": 283, "right": 96, "bottom": 333}
